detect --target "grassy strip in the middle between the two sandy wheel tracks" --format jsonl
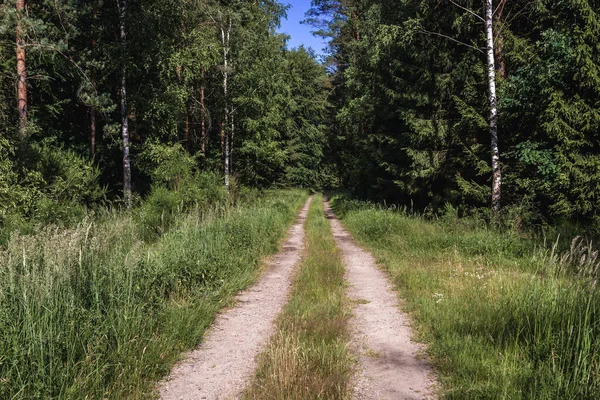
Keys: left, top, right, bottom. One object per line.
{"left": 246, "top": 196, "right": 352, "bottom": 399}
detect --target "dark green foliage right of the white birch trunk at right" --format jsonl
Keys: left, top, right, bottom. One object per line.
{"left": 503, "top": 1, "right": 600, "bottom": 220}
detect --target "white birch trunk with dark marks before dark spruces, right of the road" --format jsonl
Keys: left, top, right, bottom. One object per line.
{"left": 485, "top": 0, "right": 502, "bottom": 214}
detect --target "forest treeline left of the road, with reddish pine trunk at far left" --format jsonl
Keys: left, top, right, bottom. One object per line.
{"left": 0, "top": 0, "right": 327, "bottom": 222}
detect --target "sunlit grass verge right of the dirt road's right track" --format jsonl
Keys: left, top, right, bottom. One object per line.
{"left": 334, "top": 198, "right": 600, "bottom": 399}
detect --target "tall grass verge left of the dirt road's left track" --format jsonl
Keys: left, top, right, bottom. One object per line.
{"left": 0, "top": 191, "right": 306, "bottom": 399}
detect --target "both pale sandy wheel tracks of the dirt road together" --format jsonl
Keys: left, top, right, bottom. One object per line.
{"left": 159, "top": 198, "right": 436, "bottom": 400}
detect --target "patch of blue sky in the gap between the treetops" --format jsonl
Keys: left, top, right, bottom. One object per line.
{"left": 279, "top": 0, "right": 326, "bottom": 54}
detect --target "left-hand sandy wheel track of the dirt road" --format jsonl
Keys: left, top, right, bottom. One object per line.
{"left": 158, "top": 198, "right": 312, "bottom": 400}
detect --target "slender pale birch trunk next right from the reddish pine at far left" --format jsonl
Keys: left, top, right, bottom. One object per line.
{"left": 117, "top": 0, "right": 132, "bottom": 208}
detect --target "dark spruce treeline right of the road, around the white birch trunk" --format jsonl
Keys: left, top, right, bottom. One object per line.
{"left": 308, "top": 0, "right": 600, "bottom": 230}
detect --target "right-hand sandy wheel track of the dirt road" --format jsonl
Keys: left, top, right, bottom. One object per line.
{"left": 325, "top": 203, "right": 436, "bottom": 400}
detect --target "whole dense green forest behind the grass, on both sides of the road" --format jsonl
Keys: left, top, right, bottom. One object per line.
{"left": 0, "top": 0, "right": 600, "bottom": 232}
